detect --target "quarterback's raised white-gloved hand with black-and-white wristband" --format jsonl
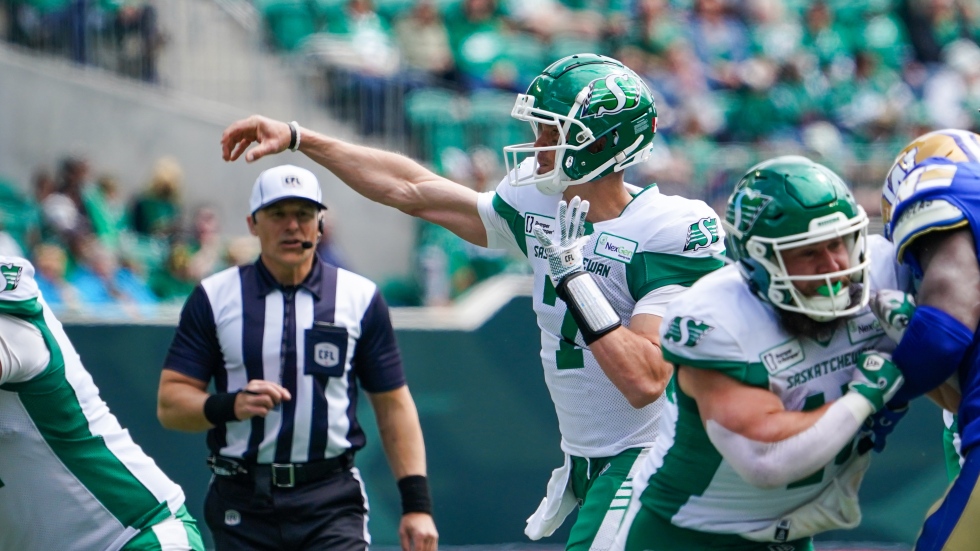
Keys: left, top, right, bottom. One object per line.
{"left": 533, "top": 197, "right": 622, "bottom": 345}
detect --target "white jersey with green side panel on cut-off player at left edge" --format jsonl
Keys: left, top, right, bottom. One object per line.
{"left": 0, "top": 256, "right": 184, "bottom": 551}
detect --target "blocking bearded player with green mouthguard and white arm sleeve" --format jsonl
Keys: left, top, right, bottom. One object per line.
{"left": 614, "top": 156, "right": 901, "bottom": 551}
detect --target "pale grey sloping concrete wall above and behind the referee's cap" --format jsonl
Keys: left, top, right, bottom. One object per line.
{"left": 0, "top": 45, "right": 415, "bottom": 278}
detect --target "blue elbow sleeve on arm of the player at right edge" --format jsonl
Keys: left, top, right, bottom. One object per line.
{"left": 892, "top": 306, "right": 973, "bottom": 403}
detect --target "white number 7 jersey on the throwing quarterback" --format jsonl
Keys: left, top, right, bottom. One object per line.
{"left": 479, "top": 171, "right": 725, "bottom": 457}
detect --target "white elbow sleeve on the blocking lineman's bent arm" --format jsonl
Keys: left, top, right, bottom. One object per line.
{"left": 705, "top": 392, "right": 872, "bottom": 489}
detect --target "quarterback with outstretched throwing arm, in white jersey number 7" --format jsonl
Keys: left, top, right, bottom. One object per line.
{"left": 221, "top": 54, "right": 724, "bottom": 550}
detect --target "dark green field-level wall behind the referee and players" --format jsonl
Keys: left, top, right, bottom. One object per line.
{"left": 66, "top": 297, "right": 946, "bottom": 546}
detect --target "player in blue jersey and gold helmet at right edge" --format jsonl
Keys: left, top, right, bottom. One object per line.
{"left": 873, "top": 130, "right": 980, "bottom": 551}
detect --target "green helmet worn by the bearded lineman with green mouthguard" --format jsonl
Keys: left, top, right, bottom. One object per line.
{"left": 722, "top": 155, "right": 870, "bottom": 321}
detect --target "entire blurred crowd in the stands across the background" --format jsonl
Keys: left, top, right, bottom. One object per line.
{"left": 0, "top": 0, "right": 980, "bottom": 310}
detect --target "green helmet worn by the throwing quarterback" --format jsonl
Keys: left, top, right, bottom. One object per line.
{"left": 504, "top": 54, "right": 657, "bottom": 195}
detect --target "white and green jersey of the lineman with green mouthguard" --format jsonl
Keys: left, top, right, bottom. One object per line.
{"left": 637, "top": 236, "right": 907, "bottom": 534}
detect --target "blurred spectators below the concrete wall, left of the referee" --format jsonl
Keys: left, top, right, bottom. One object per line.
{"left": 0, "top": 156, "right": 258, "bottom": 319}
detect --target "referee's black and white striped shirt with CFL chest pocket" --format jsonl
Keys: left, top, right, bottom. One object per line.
{"left": 165, "top": 257, "right": 405, "bottom": 463}
